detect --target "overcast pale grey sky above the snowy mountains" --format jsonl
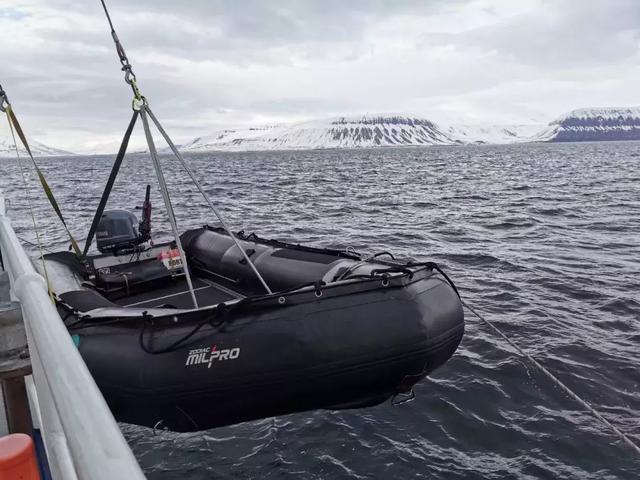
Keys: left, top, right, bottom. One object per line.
{"left": 0, "top": 0, "right": 640, "bottom": 151}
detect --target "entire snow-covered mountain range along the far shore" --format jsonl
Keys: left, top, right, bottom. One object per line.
{"left": 5, "top": 107, "right": 640, "bottom": 157}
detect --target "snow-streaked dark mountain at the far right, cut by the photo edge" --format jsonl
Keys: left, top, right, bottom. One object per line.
{"left": 534, "top": 107, "right": 640, "bottom": 142}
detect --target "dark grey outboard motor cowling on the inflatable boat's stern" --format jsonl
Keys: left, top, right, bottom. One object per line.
{"left": 96, "top": 210, "right": 140, "bottom": 253}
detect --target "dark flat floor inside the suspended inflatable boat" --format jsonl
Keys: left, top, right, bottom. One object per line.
{"left": 113, "top": 277, "right": 242, "bottom": 309}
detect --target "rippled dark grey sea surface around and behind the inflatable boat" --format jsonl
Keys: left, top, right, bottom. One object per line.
{"left": 0, "top": 142, "right": 640, "bottom": 480}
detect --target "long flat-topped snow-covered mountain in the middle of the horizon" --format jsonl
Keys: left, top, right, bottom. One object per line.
{"left": 175, "top": 115, "right": 543, "bottom": 151}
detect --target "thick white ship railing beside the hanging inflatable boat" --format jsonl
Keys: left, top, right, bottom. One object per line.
{"left": 0, "top": 194, "right": 145, "bottom": 480}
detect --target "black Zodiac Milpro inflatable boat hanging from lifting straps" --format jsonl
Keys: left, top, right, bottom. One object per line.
{"left": 40, "top": 217, "right": 464, "bottom": 431}
